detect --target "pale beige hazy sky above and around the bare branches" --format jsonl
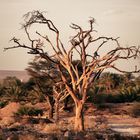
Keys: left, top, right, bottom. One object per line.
{"left": 0, "top": 0, "right": 140, "bottom": 70}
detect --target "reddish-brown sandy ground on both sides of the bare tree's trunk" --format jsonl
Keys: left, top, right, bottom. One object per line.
{"left": 0, "top": 103, "right": 140, "bottom": 139}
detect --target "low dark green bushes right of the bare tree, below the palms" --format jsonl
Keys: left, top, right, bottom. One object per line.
{"left": 88, "top": 86, "right": 140, "bottom": 104}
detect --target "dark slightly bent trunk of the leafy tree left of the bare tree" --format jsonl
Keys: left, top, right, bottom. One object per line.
{"left": 47, "top": 97, "right": 54, "bottom": 119}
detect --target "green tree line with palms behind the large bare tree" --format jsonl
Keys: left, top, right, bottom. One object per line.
{"left": 0, "top": 60, "right": 140, "bottom": 110}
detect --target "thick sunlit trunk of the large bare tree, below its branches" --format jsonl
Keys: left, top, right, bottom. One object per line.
{"left": 74, "top": 101, "right": 84, "bottom": 132}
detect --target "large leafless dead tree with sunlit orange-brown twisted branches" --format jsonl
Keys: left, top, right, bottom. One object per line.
{"left": 5, "top": 11, "right": 140, "bottom": 131}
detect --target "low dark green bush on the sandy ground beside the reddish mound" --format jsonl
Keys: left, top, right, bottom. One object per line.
{"left": 16, "top": 106, "right": 43, "bottom": 116}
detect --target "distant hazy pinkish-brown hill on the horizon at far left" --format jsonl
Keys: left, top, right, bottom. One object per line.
{"left": 0, "top": 70, "right": 30, "bottom": 82}
